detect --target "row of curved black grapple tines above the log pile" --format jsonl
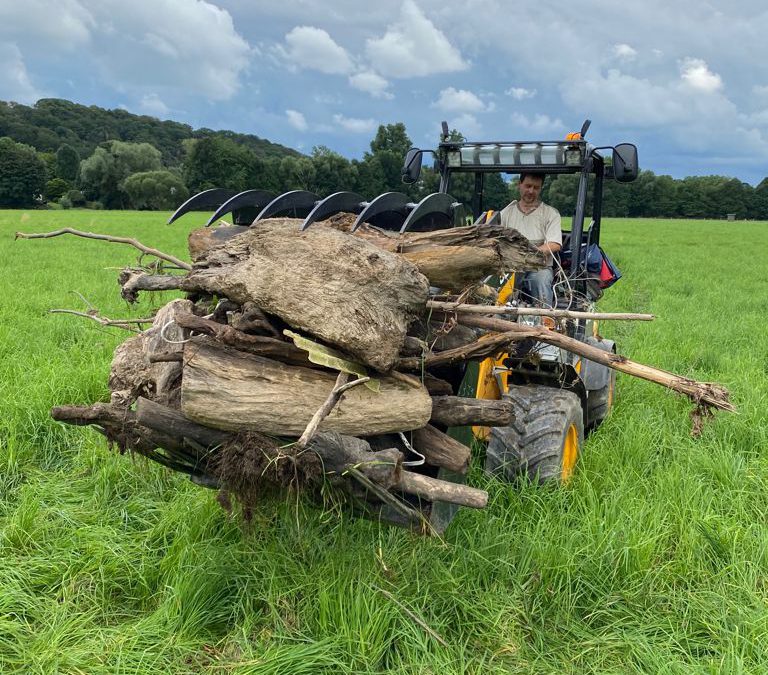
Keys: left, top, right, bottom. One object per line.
{"left": 168, "top": 188, "right": 464, "bottom": 233}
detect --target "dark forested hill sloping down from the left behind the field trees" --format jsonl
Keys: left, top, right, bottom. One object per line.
{"left": 0, "top": 98, "right": 300, "bottom": 166}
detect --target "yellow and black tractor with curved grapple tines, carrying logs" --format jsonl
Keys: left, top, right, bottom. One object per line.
{"left": 169, "top": 120, "right": 638, "bottom": 532}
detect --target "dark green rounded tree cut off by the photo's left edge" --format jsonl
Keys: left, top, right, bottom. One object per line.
{"left": 0, "top": 138, "right": 46, "bottom": 207}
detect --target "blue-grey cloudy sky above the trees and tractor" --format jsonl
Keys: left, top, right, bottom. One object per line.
{"left": 0, "top": 0, "right": 768, "bottom": 185}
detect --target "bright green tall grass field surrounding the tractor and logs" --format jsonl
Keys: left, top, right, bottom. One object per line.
{"left": 0, "top": 211, "right": 768, "bottom": 675}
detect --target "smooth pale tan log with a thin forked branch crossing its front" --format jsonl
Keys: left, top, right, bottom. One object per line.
{"left": 181, "top": 337, "right": 432, "bottom": 436}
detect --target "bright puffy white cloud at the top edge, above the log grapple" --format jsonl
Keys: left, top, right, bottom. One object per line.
{"left": 365, "top": 0, "right": 468, "bottom": 78}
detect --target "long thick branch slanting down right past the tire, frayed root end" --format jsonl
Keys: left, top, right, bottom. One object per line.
{"left": 452, "top": 314, "right": 736, "bottom": 412}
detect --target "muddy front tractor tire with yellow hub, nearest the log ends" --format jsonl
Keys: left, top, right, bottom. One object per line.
{"left": 485, "top": 385, "right": 584, "bottom": 483}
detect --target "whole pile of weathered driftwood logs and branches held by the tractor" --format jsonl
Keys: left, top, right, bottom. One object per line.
{"left": 17, "top": 216, "right": 730, "bottom": 530}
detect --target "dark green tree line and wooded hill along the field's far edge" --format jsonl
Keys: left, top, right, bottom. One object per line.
{"left": 0, "top": 99, "right": 768, "bottom": 220}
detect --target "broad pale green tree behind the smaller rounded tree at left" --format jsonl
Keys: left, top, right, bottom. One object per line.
{"left": 80, "top": 141, "right": 161, "bottom": 209}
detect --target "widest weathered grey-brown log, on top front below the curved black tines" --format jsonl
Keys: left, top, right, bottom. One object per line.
{"left": 183, "top": 219, "right": 429, "bottom": 371}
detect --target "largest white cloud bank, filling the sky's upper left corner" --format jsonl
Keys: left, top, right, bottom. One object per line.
{"left": 0, "top": 0, "right": 251, "bottom": 100}
